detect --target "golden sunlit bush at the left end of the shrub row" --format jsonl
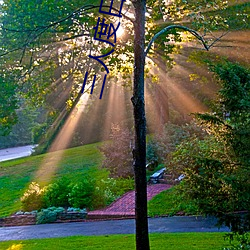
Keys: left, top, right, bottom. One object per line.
{"left": 21, "top": 182, "right": 45, "bottom": 211}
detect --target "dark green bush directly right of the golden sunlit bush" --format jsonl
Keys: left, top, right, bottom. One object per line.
{"left": 43, "top": 178, "right": 71, "bottom": 207}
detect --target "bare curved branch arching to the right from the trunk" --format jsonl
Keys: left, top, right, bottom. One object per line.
{"left": 145, "top": 25, "right": 214, "bottom": 56}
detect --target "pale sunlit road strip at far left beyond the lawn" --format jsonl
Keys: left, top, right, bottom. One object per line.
{"left": 0, "top": 145, "right": 36, "bottom": 162}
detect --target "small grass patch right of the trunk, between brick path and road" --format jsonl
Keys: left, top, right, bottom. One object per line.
{"left": 148, "top": 187, "right": 198, "bottom": 217}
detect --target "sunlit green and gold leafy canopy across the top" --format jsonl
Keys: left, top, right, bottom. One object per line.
{"left": 0, "top": 0, "right": 246, "bottom": 135}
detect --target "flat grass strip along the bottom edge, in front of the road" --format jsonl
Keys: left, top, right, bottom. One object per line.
{"left": 0, "top": 233, "right": 228, "bottom": 250}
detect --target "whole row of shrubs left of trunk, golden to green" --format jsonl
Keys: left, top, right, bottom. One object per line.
{"left": 18, "top": 166, "right": 134, "bottom": 211}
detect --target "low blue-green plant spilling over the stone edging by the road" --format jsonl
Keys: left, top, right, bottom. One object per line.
{"left": 36, "top": 207, "right": 64, "bottom": 224}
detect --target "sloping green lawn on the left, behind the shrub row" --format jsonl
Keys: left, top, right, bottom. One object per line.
{"left": 0, "top": 143, "right": 103, "bottom": 217}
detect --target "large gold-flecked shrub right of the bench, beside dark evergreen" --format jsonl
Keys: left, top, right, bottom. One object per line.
{"left": 168, "top": 137, "right": 240, "bottom": 214}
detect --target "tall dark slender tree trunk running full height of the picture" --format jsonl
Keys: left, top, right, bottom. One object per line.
{"left": 132, "top": 0, "right": 149, "bottom": 250}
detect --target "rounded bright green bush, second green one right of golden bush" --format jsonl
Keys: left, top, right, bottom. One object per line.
{"left": 68, "top": 179, "right": 94, "bottom": 208}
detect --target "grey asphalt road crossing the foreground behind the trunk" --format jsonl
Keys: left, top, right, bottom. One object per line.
{"left": 0, "top": 216, "right": 229, "bottom": 241}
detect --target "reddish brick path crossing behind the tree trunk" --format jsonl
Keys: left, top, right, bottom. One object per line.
{"left": 88, "top": 184, "right": 171, "bottom": 219}
